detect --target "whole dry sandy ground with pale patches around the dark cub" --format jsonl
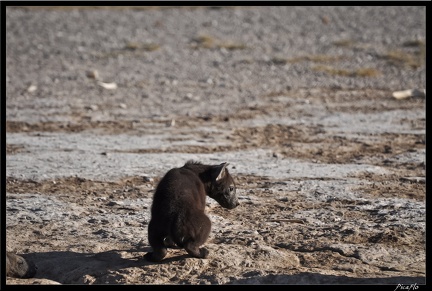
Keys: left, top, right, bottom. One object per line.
{"left": 2, "top": 7, "right": 426, "bottom": 286}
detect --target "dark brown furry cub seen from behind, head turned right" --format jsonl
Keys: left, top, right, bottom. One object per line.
{"left": 145, "top": 161, "right": 239, "bottom": 262}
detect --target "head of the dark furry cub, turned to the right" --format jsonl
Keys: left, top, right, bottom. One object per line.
{"left": 208, "top": 163, "right": 239, "bottom": 209}
